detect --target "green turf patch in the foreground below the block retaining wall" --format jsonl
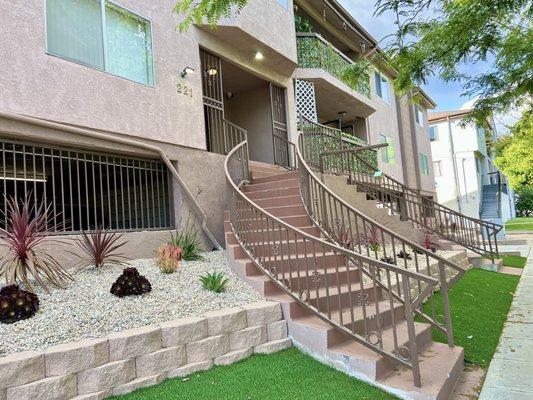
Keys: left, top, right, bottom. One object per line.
{"left": 114, "top": 349, "right": 395, "bottom": 400}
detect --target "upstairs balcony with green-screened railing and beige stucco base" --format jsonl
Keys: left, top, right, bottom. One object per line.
{"left": 293, "top": 32, "right": 375, "bottom": 119}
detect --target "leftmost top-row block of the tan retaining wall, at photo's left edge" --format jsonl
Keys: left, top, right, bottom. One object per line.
{"left": 0, "top": 352, "right": 45, "bottom": 390}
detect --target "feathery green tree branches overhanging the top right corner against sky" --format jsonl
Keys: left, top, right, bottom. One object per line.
{"left": 376, "top": 0, "right": 533, "bottom": 124}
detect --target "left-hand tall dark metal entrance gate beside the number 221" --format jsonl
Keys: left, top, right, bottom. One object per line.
{"left": 200, "top": 49, "right": 225, "bottom": 154}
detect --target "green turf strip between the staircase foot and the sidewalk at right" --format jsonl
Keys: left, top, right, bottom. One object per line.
{"left": 425, "top": 269, "right": 520, "bottom": 367}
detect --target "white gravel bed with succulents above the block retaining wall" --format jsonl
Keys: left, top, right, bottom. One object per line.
{"left": 0, "top": 251, "right": 263, "bottom": 356}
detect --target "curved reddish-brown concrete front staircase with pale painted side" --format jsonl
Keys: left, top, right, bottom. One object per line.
{"left": 225, "top": 163, "right": 463, "bottom": 399}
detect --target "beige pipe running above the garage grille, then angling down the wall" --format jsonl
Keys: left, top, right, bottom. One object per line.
{"left": 0, "top": 111, "right": 222, "bottom": 250}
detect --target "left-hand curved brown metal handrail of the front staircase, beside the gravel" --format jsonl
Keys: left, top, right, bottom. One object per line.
{"left": 224, "top": 136, "right": 453, "bottom": 386}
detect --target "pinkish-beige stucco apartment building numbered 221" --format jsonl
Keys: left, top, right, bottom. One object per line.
{"left": 0, "top": 0, "right": 435, "bottom": 256}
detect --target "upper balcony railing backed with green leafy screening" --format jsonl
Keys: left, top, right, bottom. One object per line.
{"left": 296, "top": 32, "right": 370, "bottom": 97}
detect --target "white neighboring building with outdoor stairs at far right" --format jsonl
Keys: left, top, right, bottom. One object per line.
{"left": 429, "top": 110, "right": 515, "bottom": 228}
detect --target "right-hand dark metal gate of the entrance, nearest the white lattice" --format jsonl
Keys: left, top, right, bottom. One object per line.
{"left": 270, "top": 83, "right": 291, "bottom": 168}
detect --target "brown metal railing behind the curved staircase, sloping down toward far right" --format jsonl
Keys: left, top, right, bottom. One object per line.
{"left": 301, "top": 117, "right": 502, "bottom": 260}
